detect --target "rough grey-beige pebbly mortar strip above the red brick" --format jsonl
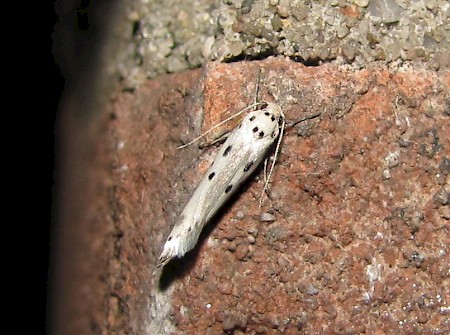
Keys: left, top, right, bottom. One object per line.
{"left": 117, "top": 0, "right": 450, "bottom": 86}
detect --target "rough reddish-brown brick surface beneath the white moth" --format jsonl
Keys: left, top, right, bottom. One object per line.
{"left": 58, "top": 58, "right": 450, "bottom": 334}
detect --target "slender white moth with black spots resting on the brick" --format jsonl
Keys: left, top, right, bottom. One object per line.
{"left": 157, "top": 102, "right": 285, "bottom": 267}
